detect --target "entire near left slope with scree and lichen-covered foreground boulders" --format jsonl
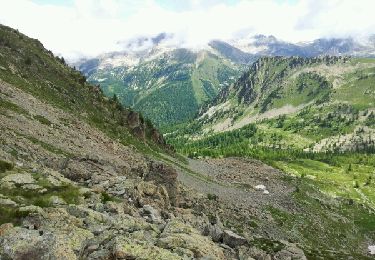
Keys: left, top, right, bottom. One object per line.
{"left": 0, "top": 26, "right": 312, "bottom": 259}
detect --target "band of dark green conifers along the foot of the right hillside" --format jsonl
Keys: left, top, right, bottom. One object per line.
{"left": 169, "top": 120, "right": 375, "bottom": 166}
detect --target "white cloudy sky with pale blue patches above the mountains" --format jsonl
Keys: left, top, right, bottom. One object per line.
{"left": 0, "top": 0, "right": 375, "bottom": 59}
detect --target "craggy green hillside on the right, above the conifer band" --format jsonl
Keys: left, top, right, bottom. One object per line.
{"left": 173, "top": 57, "right": 375, "bottom": 151}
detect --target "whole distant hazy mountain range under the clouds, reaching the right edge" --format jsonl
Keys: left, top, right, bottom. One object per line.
{"left": 72, "top": 33, "right": 375, "bottom": 127}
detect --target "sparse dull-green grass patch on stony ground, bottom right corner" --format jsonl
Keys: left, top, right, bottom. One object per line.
{"left": 264, "top": 178, "right": 375, "bottom": 259}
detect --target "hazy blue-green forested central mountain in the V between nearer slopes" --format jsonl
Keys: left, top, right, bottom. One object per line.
{"left": 79, "top": 49, "right": 244, "bottom": 126}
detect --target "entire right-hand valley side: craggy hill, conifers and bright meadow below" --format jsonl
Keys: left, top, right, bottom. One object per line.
{"left": 165, "top": 56, "right": 375, "bottom": 217}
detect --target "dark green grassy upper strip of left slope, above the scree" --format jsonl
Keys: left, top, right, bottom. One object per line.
{"left": 0, "top": 25, "right": 173, "bottom": 151}
